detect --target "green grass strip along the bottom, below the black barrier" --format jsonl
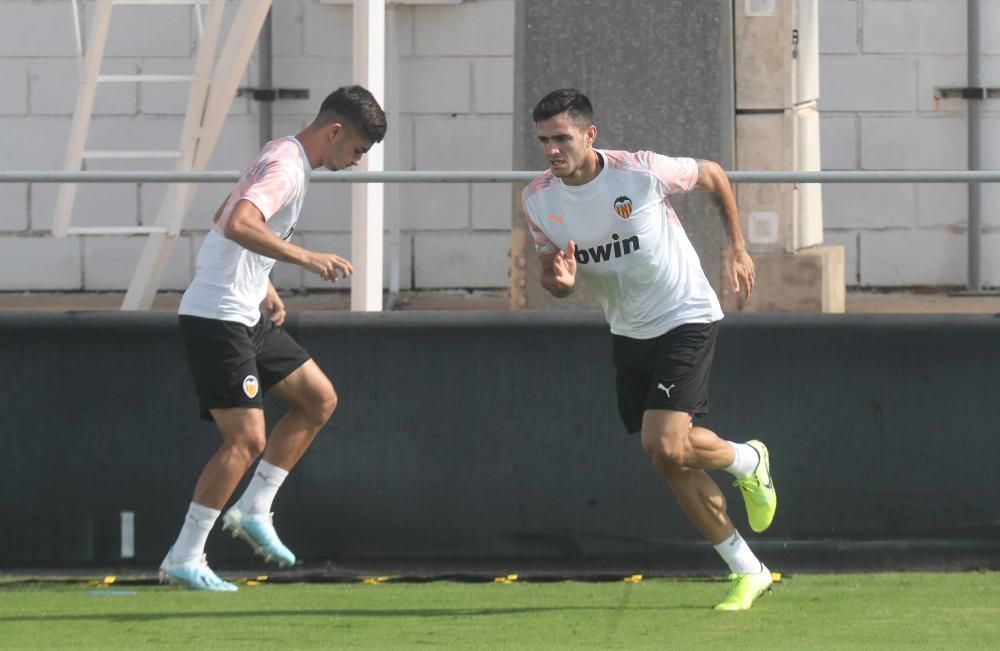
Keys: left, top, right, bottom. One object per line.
{"left": 0, "top": 572, "right": 1000, "bottom": 650}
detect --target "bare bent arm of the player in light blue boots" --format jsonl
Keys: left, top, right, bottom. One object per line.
{"left": 222, "top": 199, "right": 354, "bottom": 281}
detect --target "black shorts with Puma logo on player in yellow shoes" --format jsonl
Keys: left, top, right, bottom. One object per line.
{"left": 612, "top": 322, "right": 719, "bottom": 434}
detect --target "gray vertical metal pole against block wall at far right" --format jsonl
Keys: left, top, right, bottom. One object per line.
{"left": 966, "top": 0, "right": 982, "bottom": 292}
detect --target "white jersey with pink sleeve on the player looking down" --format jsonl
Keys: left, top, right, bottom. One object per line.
{"left": 178, "top": 136, "right": 312, "bottom": 327}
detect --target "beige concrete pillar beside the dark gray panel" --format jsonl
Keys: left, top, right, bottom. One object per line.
{"left": 733, "top": 0, "right": 824, "bottom": 262}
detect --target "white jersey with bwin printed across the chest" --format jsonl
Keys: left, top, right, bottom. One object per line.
{"left": 522, "top": 150, "right": 722, "bottom": 339}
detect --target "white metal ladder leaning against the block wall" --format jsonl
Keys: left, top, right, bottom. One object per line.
{"left": 52, "top": 0, "right": 272, "bottom": 310}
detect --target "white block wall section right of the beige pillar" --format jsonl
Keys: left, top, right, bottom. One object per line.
{"left": 819, "top": 0, "right": 1000, "bottom": 287}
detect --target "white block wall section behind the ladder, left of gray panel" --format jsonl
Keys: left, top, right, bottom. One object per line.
{"left": 0, "top": 0, "right": 514, "bottom": 291}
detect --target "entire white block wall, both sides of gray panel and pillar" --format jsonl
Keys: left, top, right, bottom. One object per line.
{"left": 0, "top": 0, "right": 1000, "bottom": 291}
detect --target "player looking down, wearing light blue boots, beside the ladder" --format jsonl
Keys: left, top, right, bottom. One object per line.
{"left": 160, "top": 86, "right": 386, "bottom": 591}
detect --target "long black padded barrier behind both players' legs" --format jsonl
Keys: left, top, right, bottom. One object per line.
{"left": 0, "top": 312, "right": 1000, "bottom": 569}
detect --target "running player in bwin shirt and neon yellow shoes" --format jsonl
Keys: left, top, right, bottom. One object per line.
{"left": 522, "top": 89, "right": 777, "bottom": 610}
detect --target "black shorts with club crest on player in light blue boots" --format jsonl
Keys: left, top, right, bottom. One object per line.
{"left": 178, "top": 313, "right": 309, "bottom": 420}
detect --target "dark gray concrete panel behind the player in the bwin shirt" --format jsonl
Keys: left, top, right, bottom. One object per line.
{"left": 512, "top": 0, "right": 734, "bottom": 310}
